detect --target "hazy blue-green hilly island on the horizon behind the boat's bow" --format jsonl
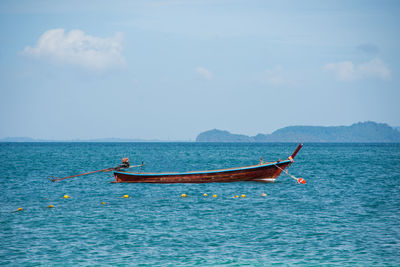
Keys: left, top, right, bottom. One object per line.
{"left": 196, "top": 121, "right": 400, "bottom": 143}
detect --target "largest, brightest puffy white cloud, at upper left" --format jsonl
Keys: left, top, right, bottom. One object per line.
{"left": 23, "top": 29, "right": 125, "bottom": 70}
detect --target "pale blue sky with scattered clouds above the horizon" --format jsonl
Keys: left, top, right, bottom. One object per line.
{"left": 0, "top": 0, "right": 400, "bottom": 141}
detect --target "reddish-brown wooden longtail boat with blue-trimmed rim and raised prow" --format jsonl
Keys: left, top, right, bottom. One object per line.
{"left": 113, "top": 143, "right": 303, "bottom": 183}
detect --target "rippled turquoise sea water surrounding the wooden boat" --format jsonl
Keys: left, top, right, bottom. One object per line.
{"left": 0, "top": 143, "right": 400, "bottom": 266}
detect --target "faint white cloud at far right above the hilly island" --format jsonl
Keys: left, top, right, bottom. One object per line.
{"left": 324, "top": 58, "right": 390, "bottom": 81}
